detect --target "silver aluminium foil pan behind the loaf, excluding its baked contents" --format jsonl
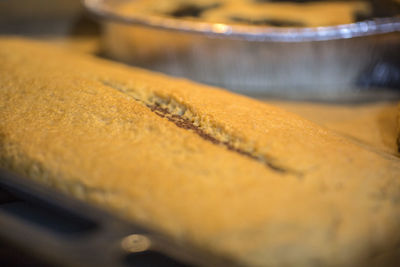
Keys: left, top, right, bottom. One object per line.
{"left": 84, "top": 0, "right": 400, "bottom": 101}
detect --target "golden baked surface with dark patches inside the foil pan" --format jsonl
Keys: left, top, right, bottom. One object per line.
{"left": 114, "top": 0, "right": 400, "bottom": 27}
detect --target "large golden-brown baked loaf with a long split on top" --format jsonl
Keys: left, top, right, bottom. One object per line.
{"left": 0, "top": 37, "right": 400, "bottom": 266}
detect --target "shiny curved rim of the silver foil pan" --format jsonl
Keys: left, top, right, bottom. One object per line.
{"left": 83, "top": 0, "right": 400, "bottom": 42}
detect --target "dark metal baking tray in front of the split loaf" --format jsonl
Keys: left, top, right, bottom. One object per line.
{"left": 0, "top": 169, "right": 235, "bottom": 267}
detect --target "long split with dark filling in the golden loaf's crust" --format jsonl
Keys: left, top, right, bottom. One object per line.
{"left": 100, "top": 80, "right": 303, "bottom": 178}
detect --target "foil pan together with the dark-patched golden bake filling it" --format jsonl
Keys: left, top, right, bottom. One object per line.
{"left": 85, "top": 0, "right": 400, "bottom": 101}
